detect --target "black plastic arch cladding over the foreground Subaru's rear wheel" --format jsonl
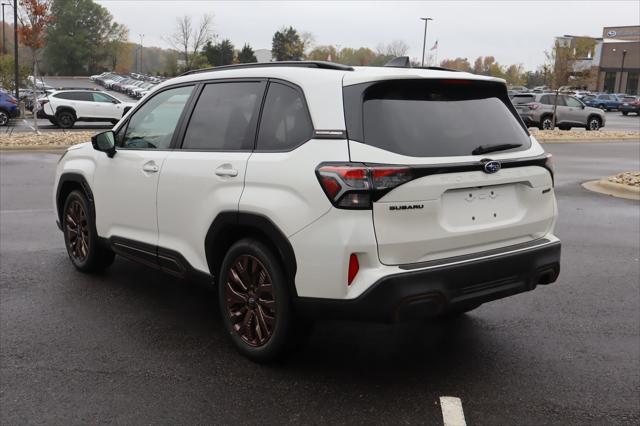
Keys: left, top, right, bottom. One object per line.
{"left": 204, "top": 211, "right": 297, "bottom": 297}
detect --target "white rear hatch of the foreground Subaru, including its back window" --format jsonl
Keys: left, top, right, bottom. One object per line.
{"left": 344, "top": 79, "right": 556, "bottom": 265}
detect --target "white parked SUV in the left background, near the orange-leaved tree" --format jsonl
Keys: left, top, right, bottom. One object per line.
{"left": 38, "top": 89, "right": 135, "bottom": 129}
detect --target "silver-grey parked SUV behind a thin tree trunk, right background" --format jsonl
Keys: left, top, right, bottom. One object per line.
{"left": 511, "top": 93, "right": 605, "bottom": 130}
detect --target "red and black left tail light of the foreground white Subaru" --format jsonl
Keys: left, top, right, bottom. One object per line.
{"left": 316, "top": 164, "right": 414, "bottom": 210}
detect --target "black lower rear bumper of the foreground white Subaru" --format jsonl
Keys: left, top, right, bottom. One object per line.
{"left": 295, "top": 240, "right": 561, "bottom": 322}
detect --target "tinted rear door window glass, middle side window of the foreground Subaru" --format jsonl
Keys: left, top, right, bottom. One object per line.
{"left": 182, "top": 82, "right": 265, "bottom": 151}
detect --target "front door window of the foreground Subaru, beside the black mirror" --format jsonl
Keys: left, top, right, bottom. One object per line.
{"left": 117, "top": 86, "right": 193, "bottom": 149}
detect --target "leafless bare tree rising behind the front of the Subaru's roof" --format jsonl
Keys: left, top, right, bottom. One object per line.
{"left": 168, "top": 15, "right": 213, "bottom": 71}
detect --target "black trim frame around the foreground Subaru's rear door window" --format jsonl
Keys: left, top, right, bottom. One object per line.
{"left": 174, "top": 77, "right": 268, "bottom": 152}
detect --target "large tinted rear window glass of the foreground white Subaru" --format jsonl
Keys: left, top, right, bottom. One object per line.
{"left": 347, "top": 80, "right": 531, "bottom": 157}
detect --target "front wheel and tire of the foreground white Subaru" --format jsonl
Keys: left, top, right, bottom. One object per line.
{"left": 62, "top": 190, "right": 115, "bottom": 272}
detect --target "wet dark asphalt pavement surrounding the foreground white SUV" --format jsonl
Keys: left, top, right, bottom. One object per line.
{"left": 0, "top": 142, "right": 640, "bottom": 425}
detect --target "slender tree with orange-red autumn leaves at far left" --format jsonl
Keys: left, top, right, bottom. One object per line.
{"left": 18, "top": 0, "right": 53, "bottom": 133}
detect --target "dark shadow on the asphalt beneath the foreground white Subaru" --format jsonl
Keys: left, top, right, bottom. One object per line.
{"left": 90, "top": 253, "right": 495, "bottom": 380}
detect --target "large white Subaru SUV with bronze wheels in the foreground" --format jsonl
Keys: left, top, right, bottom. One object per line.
{"left": 53, "top": 62, "right": 560, "bottom": 361}
